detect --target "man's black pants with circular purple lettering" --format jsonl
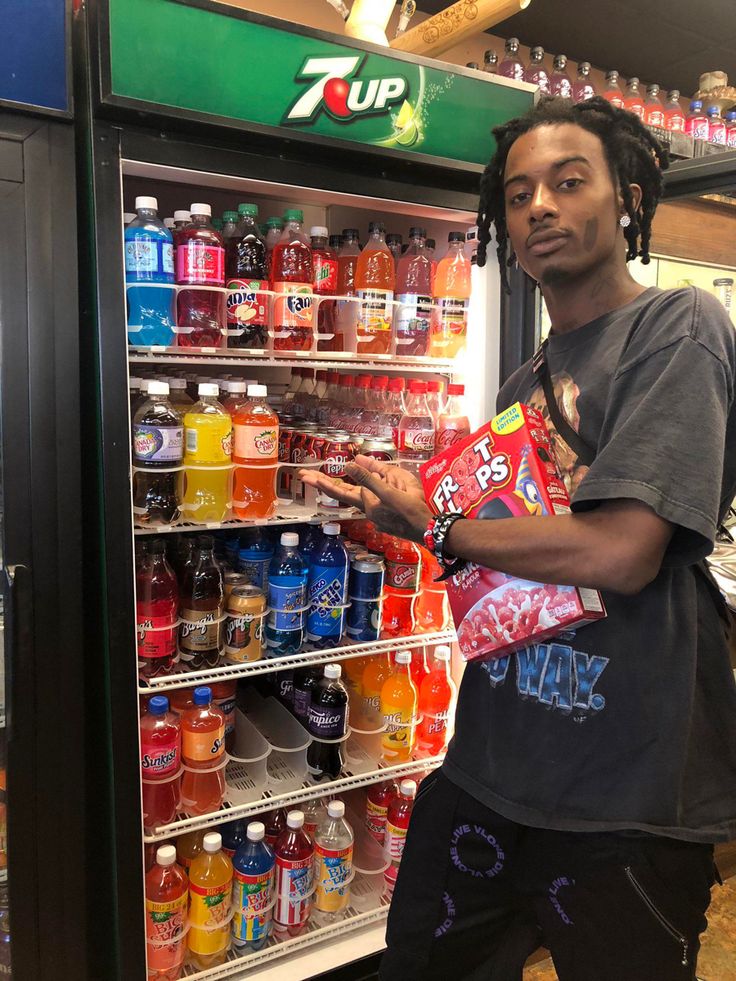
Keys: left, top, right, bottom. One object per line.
{"left": 380, "top": 771, "right": 714, "bottom": 981}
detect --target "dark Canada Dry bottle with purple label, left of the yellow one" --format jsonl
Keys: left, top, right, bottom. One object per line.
{"left": 133, "top": 382, "right": 184, "bottom": 525}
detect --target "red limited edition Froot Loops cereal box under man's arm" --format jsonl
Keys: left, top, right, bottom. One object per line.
{"left": 420, "top": 402, "right": 606, "bottom": 660}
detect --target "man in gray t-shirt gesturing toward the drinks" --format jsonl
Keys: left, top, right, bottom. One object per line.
{"left": 305, "top": 99, "right": 736, "bottom": 981}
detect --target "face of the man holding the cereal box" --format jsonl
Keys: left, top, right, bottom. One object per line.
{"left": 504, "top": 123, "right": 622, "bottom": 286}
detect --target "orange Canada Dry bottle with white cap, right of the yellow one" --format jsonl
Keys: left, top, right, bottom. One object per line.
{"left": 233, "top": 385, "right": 279, "bottom": 520}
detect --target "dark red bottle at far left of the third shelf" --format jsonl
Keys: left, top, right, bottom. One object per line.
{"left": 135, "top": 539, "right": 179, "bottom": 678}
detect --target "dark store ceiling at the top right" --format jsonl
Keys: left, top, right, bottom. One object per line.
{"left": 419, "top": 0, "right": 736, "bottom": 96}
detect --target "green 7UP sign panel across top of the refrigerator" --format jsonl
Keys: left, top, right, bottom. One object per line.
{"left": 109, "top": 0, "right": 533, "bottom": 164}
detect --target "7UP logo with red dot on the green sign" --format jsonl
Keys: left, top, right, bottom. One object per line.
{"left": 283, "top": 55, "right": 409, "bottom": 124}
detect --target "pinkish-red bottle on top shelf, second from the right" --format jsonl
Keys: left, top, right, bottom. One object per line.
{"left": 395, "top": 227, "right": 432, "bottom": 355}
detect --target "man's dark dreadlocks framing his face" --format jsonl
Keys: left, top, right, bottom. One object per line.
{"left": 478, "top": 97, "right": 669, "bottom": 292}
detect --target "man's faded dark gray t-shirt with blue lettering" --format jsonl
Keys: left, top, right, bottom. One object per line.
{"left": 444, "top": 288, "right": 736, "bottom": 842}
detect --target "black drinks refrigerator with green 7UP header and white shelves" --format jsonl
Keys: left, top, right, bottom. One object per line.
{"left": 74, "top": 0, "right": 534, "bottom": 981}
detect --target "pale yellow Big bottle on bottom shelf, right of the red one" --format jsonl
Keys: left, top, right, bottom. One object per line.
{"left": 314, "top": 800, "right": 354, "bottom": 922}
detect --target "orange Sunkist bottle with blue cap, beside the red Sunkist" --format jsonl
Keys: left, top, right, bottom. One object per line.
{"left": 181, "top": 686, "right": 225, "bottom": 816}
